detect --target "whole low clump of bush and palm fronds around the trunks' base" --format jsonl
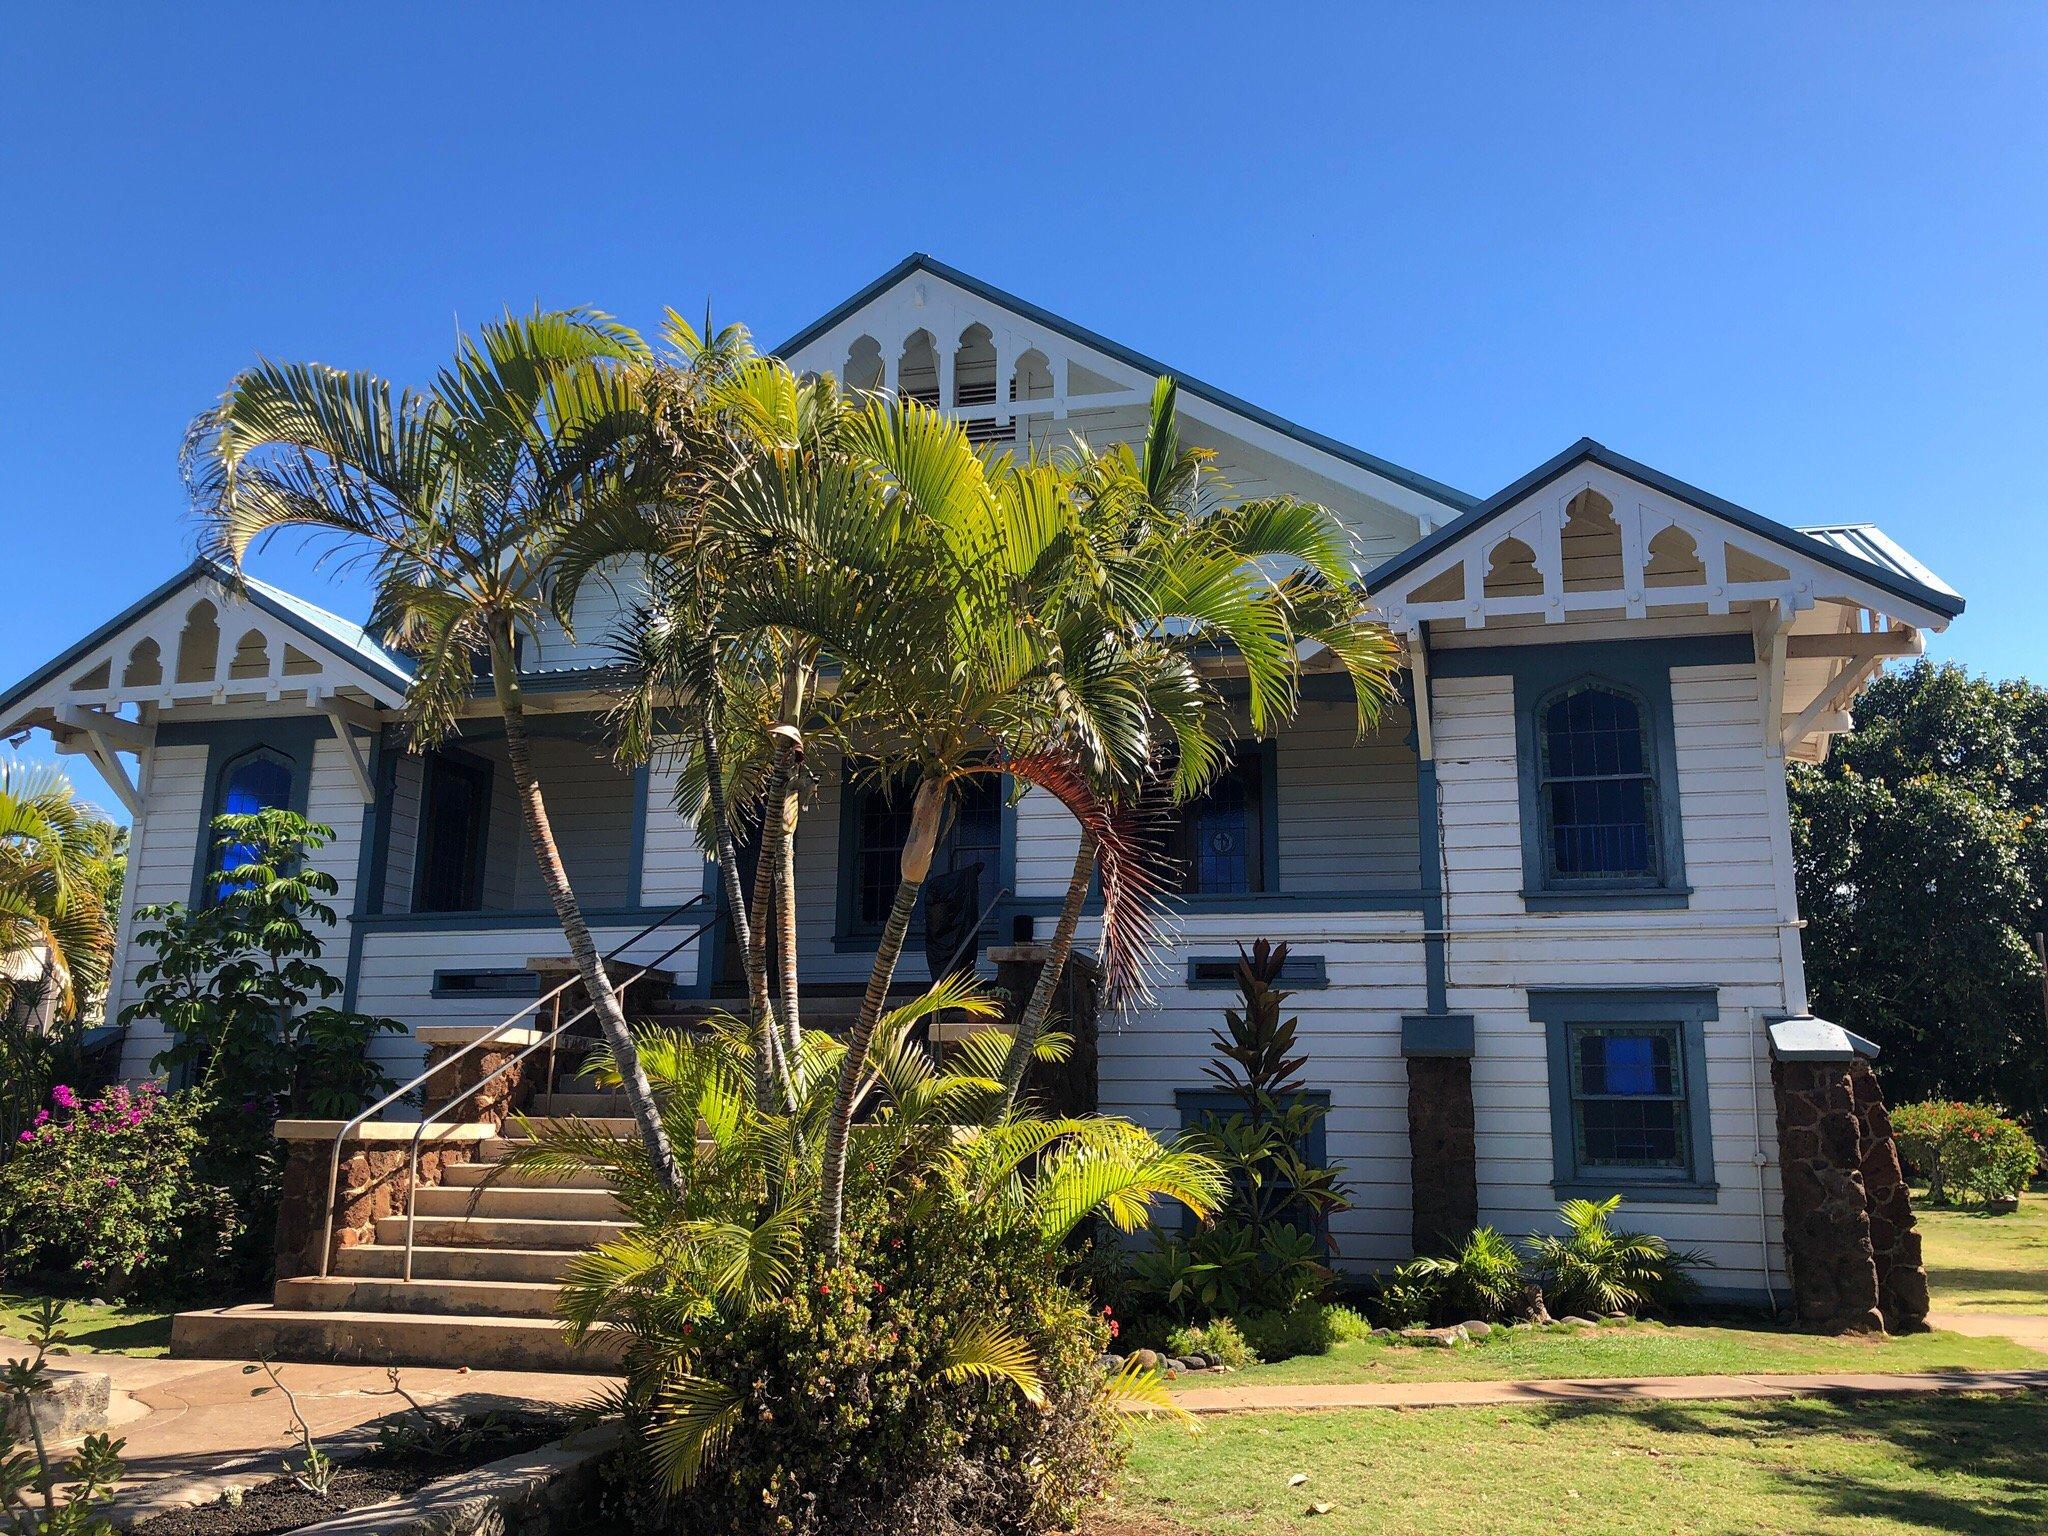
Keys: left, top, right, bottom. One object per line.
{"left": 504, "top": 977, "right": 1223, "bottom": 1528}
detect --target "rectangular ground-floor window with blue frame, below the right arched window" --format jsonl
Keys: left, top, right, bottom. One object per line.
{"left": 1530, "top": 987, "right": 1716, "bottom": 1200}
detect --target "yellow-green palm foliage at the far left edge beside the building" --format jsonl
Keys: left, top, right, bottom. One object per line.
{"left": 0, "top": 760, "right": 121, "bottom": 1028}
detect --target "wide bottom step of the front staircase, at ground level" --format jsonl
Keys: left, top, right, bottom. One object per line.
{"left": 170, "top": 1303, "right": 621, "bottom": 1372}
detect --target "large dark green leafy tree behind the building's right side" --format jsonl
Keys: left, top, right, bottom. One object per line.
{"left": 1790, "top": 662, "right": 2048, "bottom": 1124}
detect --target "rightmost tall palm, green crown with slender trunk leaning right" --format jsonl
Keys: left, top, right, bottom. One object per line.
{"left": 987, "top": 379, "right": 1393, "bottom": 1102}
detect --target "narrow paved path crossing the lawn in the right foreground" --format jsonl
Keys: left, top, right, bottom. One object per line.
{"left": 1171, "top": 1370, "right": 2048, "bottom": 1413}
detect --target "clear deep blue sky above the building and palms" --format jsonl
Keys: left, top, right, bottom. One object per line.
{"left": 0, "top": 2, "right": 2048, "bottom": 819}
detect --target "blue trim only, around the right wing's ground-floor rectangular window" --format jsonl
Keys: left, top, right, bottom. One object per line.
{"left": 1530, "top": 987, "right": 1720, "bottom": 1204}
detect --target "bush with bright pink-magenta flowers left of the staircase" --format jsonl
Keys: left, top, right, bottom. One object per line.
{"left": 0, "top": 1083, "right": 244, "bottom": 1296}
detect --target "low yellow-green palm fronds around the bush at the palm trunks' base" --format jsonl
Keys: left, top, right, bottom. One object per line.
{"left": 502, "top": 991, "right": 1225, "bottom": 1493}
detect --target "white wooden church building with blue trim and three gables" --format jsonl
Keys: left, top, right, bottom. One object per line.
{"left": 0, "top": 256, "right": 1962, "bottom": 1335}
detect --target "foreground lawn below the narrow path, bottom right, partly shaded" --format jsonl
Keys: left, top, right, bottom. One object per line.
{"left": 1105, "top": 1395, "right": 2048, "bottom": 1536}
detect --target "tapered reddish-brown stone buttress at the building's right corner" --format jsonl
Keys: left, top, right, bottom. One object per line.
{"left": 1772, "top": 1059, "right": 1927, "bottom": 1333}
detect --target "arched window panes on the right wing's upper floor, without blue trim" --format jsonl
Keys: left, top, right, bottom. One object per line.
{"left": 1536, "top": 682, "right": 1659, "bottom": 885}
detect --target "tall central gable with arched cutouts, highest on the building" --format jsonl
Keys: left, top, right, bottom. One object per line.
{"left": 776, "top": 254, "right": 1473, "bottom": 555}
